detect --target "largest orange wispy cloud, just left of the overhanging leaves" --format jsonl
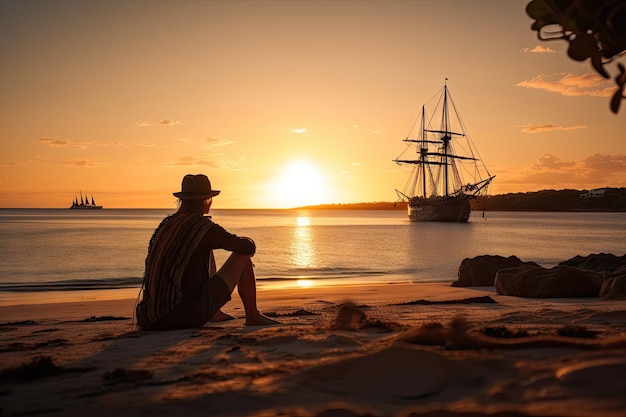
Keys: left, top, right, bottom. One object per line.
{"left": 516, "top": 73, "right": 615, "bottom": 97}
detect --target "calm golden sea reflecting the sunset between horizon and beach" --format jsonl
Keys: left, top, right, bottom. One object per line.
{"left": 0, "top": 209, "right": 626, "bottom": 303}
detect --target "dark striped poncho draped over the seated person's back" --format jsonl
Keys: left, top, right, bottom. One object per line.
{"left": 136, "top": 212, "right": 214, "bottom": 328}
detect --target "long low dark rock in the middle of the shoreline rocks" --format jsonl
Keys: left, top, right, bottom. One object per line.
{"left": 494, "top": 265, "right": 603, "bottom": 298}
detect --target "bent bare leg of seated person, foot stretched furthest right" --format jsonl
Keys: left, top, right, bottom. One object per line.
{"left": 217, "top": 253, "right": 279, "bottom": 326}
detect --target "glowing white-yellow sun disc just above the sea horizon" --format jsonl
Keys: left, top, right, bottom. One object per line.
{"left": 270, "top": 160, "right": 329, "bottom": 208}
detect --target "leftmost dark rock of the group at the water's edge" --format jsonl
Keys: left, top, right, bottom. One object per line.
{"left": 452, "top": 255, "right": 539, "bottom": 287}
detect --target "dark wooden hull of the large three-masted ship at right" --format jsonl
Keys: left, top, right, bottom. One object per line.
{"left": 407, "top": 195, "right": 470, "bottom": 223}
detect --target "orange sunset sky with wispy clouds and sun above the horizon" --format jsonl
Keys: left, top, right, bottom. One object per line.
{"left": 0, "top": 0, "right": 626, "bottom": 208}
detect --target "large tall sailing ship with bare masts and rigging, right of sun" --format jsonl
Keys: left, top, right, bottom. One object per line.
{"left": 394, "top": 83, "right": 495, "bottom": 222}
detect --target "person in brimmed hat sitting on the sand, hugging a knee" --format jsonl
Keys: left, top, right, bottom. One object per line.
{"left": 136, "top": 174, "right": 278, "bottom": 330}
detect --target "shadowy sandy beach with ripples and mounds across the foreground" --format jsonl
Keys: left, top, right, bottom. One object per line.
{"left": 0, "top": 282, "right": 626, "bottom": 417}
